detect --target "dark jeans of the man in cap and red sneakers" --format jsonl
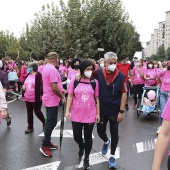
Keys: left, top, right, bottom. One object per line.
{"left": 42, "top": 106, "right": 58, "bottom": 147}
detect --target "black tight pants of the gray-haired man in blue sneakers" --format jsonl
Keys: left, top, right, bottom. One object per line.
{"left": 97, "top": 114, "right": 119, "bottom": 155}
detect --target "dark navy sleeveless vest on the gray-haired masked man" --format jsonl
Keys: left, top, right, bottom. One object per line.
{"left": 97, "top": 69, "right": 125, "bottom": 116}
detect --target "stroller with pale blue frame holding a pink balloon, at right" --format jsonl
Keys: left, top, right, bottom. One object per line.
{"left": 137, "top": 86, "right": 160, "bottom": 120}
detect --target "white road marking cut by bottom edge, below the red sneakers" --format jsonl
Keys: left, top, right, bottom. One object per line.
{"left": 22, "top": 161, "right": 61, "bottom": 170}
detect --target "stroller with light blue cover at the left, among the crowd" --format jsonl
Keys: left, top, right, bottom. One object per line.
{"left": 7, "top": 71, "right": 20, "bottom": 99}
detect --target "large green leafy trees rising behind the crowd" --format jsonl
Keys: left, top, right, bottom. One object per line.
{"left": 0, "top": 0, "right": 142, "bottom": 60}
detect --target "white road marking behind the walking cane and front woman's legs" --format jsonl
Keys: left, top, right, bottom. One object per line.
{"left": 39, "top": 129, "right": 94, "bottom": 138}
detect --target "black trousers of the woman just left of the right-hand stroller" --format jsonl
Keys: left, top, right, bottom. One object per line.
{"left": 133, "top": 84, "right": 144, "bottom": 104}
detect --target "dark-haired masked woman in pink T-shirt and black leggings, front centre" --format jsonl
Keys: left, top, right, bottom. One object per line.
{"left": 65, "top": 60, "right": 100, "bottom": 169}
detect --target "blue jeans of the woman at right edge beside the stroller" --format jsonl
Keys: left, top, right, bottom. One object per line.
{"left": 160, "top": 90, "right": 170, "bottom": 124}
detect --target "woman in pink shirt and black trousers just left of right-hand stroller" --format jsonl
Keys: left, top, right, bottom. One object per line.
{"left": 131, "top": 60, "right": 145, "bottom": 108}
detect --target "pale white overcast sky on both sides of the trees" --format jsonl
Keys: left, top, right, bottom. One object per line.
{"left": 0, "top": 0, "right": 170, "bottom": 47}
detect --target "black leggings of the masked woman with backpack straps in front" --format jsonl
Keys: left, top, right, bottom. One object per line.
{"left": 72, "top": 122, "right": 94, "bottom": 159}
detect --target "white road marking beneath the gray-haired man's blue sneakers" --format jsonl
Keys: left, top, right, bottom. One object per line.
{"left": 64, "top": 147, "right": 120, "bottom": 170}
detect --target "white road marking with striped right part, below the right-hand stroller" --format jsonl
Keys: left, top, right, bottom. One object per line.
{"left": 136, "top": 139, "right": 157, "bottom": 153}
